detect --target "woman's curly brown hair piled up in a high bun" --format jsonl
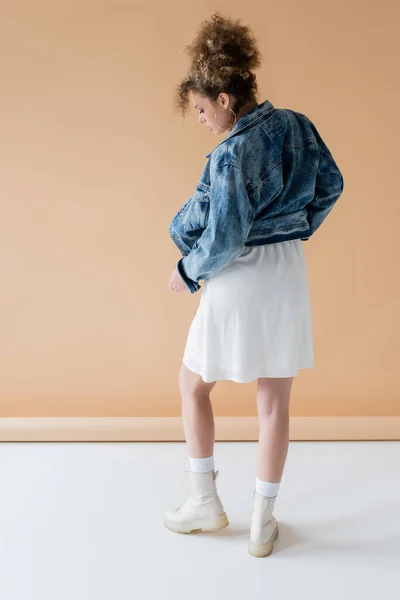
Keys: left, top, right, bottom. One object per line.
{"left": 174, "top": 12, "right": 261, "bottom": 116}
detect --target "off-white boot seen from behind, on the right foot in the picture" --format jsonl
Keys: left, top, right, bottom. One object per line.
{"left": 249, "top": 492, "right": 279, "bottom": 558}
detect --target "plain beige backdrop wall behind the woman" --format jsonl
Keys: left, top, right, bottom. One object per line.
{"left": 0, "top": 0, "right": 400, "bottom": 417}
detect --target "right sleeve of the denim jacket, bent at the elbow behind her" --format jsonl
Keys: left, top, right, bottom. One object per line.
{"left": 307, "top": 121, "right": 343, "bottom": 235}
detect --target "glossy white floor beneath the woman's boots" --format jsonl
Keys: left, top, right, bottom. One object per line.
{"left": 0, "top": 442, "right": 400, "bottom": 600}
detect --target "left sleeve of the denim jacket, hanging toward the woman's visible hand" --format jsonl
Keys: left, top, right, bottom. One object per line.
{"left": 177, "top": 164, "right": 254, "bottom": 294}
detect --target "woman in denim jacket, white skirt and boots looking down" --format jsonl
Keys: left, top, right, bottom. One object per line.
{"left": 164, "top": 13, "right": 343, "bottom": 557}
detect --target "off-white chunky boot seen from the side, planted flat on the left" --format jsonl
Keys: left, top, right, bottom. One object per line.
{"left": 164, "top": 469, "right": 229, "bottom": 533}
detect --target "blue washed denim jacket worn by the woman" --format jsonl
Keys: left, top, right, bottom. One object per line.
{"left": 169, "top": 100, "right": 343, "bottom": 294}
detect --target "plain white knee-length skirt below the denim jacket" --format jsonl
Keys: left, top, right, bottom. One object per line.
{"left": 183, "top": 239, "right": 314, "bottom": 383}
